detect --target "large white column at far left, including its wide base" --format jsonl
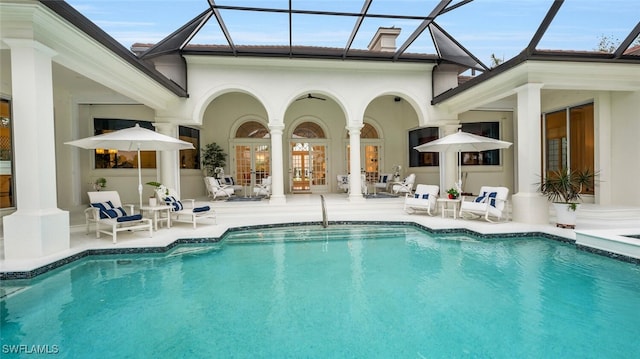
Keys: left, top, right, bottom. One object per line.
{"left": 3, "top": 39, "right": 69, "bottom": 260}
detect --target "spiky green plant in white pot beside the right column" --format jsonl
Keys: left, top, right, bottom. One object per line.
{"left": 537, "top": 169, "right": 598, "bottom": 229}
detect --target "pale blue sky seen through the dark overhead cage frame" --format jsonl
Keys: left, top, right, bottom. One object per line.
{"left": 67, "top": 0, "right": 640, "bottom": 64}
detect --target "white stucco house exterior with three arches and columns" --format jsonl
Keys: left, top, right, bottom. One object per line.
{"left": 0, "top": 1, "right": 640, "bottom": 258}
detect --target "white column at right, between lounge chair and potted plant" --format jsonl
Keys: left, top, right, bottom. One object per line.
{"left": 511, "top": 84, "right": 549, "bottom": 224}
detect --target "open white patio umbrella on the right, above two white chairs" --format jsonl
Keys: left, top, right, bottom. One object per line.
{"left": 414, "top": 130, "right": 512, "bottom": 191}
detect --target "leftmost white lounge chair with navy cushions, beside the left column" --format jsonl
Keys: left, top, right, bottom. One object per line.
{"left": 84, "top": 191, "right": 153, "bottom": 244}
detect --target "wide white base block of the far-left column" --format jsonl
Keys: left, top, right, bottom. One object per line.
{"left": 2, "top": 208, "right": 70, "bottom": 260}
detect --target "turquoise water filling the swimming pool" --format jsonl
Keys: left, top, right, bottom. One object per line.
{"left": 0, "top": 226, "right": 640, "bottom": 358}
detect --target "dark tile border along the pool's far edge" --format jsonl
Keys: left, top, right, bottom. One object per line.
{"left": 0, "top": 221, "right": 640, "bottom": 281}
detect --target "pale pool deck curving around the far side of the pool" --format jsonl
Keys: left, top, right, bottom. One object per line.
{"left": 0, "top": 193, "right": 640, "bottom": 273}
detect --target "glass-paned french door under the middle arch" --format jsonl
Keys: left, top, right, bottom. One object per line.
{"left": 290, "top": 142, "right": 327, "bottom": 192}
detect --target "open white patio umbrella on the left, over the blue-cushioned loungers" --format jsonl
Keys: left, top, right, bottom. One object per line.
{"left": 65, "top": 123, "right": 195, "bottom": 207}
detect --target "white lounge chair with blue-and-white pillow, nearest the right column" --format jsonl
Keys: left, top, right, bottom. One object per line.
{"left": 460, "top": 186, "right": 509, "bottom": 223}
